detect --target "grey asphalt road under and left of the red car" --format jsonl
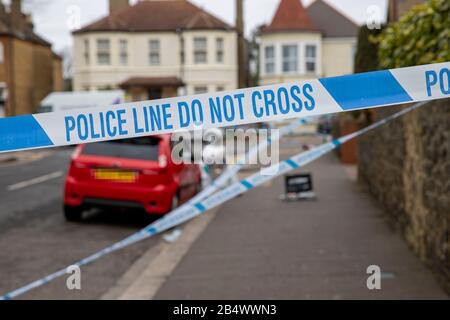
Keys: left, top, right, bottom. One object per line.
{"left": 0, "top": 148, "right": 159, "bottom": 299}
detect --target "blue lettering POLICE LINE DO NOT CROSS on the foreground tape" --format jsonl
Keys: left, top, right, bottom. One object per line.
{"left": 64, "top": 87, "right": 315, "bottom": 142}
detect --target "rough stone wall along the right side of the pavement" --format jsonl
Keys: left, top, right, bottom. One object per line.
{"left": 358, "top": 99, "right": 450, "bottom": 292}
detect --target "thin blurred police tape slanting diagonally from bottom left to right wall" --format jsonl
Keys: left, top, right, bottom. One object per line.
{"left": 0, "top": 102, "right": 427, "bottom": 300}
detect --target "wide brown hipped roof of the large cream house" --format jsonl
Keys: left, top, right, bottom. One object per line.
{"left": 74, "top": 0, "right": 232, "bottom": 34}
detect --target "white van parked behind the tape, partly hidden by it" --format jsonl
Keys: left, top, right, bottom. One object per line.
{"left": 38, "top": 90, "right": 125, "bottom": 113}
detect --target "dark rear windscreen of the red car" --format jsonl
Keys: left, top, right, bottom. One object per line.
{"left": 82, "top": 137, "right": 161, "bottom": 161}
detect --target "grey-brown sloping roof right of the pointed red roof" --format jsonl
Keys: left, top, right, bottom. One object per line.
{"left": 306, "top": 0, "right": 359, "bottom": 37}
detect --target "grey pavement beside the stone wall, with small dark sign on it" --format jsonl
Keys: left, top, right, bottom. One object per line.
{"left": 107, "top": 144, "right": 449, "bottom": 299}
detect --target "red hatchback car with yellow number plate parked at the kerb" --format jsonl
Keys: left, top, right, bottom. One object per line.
{"left": 64, "top": 135, "right": 201, "bottom": 221}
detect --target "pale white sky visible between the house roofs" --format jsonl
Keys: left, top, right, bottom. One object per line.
{"left": 18, "top": 0, "right": 387, "bottom": 53}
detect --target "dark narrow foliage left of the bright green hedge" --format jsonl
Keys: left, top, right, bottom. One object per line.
{"left": 355, "top": 26, "right": 382, "bottom": 73}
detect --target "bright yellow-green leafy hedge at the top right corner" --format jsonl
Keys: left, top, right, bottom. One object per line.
{"left": 378, "top": 0, "right": 450, "bottom": 69}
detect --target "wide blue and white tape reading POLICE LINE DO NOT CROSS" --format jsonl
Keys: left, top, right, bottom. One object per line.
{"left": 0, "top": 62, "right": 450, "bottom": 152}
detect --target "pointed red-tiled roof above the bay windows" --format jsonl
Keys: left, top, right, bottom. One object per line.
{"left": 261, "top": 0, "right": 319, "bottom": 33}
